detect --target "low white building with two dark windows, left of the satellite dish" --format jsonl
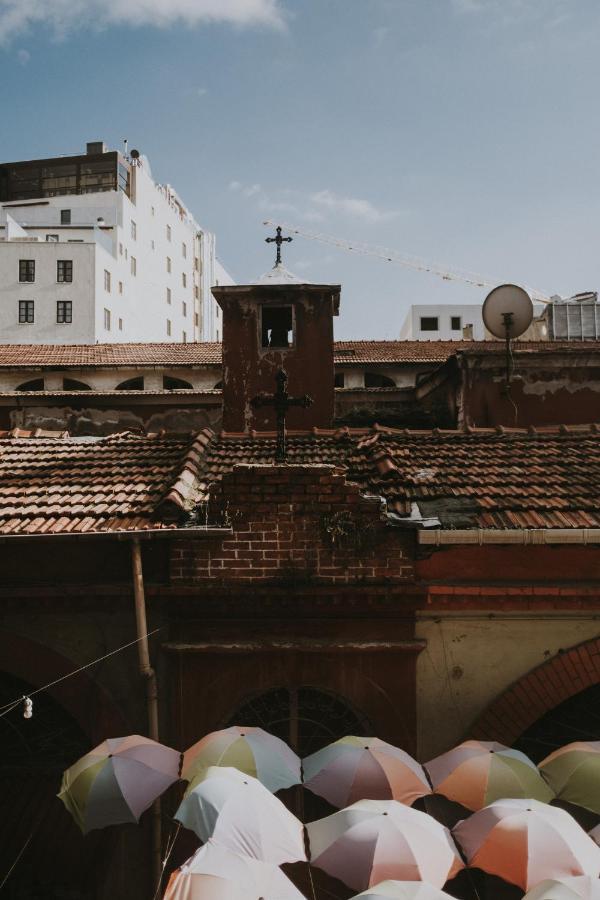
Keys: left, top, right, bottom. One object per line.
{"left": 400, "top": 303, "right": 485, "bottom": 341}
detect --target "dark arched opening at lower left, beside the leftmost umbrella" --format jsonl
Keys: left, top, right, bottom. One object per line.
{"left": 0, "top": 672, "right": 114, "bottom": 900}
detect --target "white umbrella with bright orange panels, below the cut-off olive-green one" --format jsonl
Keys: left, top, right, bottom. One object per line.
{"left": 453, "top": 800, "right": 600, "bottom": 891}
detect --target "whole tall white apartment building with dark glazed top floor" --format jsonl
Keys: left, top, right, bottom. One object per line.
{"left": 0, "top": 142, "right": 232, "bottom": 344}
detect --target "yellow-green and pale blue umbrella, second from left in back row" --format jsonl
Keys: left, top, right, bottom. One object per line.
{"left": 181, "top": 725, "right": 302, "bottom": 792}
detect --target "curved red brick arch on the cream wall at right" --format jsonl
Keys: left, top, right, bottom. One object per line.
{"left": 468, "top": 638, "right": 600, "bottom": 746}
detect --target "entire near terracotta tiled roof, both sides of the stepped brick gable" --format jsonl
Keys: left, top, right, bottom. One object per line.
{"left": 0, "top": 425, "right": 600, "bottom": 535}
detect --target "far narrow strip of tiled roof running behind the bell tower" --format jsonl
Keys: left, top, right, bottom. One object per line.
{"left": 0, "top": 341, "right": 600, "bottom": 368}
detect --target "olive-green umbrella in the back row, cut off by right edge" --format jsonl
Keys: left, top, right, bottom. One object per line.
{"left": 540, "top": 741, "right": 600, "bottom": 814}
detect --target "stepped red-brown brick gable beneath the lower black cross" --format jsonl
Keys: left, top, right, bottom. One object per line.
{"left": 171, "top": 465, "right": 413, "bottom": 584}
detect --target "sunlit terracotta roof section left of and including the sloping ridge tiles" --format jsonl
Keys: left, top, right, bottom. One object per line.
{"left": 0, "top": 429, "right": 206, "bottom": 534}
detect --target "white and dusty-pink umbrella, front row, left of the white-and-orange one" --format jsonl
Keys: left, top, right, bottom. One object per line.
{"left": 306, "top": 800, "right": 463, "bottom": 890}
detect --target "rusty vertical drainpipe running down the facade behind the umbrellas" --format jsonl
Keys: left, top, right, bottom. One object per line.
{"left": 131, "top": 538, "right": 162, "bottom": 893}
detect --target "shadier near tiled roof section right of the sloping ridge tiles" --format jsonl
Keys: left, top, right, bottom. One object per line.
{"left": 200, "top": 426, "right": 600, "bottom": 528}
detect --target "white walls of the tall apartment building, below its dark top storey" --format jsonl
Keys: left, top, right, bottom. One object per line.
{"left": 0, "top": 146, "right": 231, "bottom": 344}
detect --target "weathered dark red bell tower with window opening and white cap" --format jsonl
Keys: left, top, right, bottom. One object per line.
{"left": 212, "top": 266, "right": 340, "bottom": 432}
